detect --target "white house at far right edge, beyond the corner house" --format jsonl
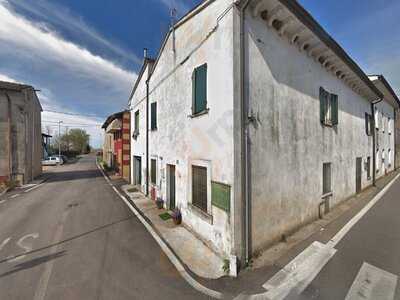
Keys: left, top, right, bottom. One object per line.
{"left": 369, "top": 75, "right": 400, "bottom": 178}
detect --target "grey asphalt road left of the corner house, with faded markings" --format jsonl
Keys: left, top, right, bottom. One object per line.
{"left": 0, "top": 156, "right": 207, "bottom": 300}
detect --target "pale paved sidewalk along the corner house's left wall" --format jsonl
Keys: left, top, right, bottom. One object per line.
{"left": 120, "top": 184, "right": 226, "bottom": 279}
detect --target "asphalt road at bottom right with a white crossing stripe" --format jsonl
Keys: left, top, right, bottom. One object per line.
{"left": 300, "top": 178, "right": 400, "bottom": 300}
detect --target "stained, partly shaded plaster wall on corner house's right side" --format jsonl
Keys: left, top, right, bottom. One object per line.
{"left": 245, "top": 10, "right": 372, "bottom": 251}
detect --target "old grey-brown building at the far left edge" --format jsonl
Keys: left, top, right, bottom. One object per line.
{"left": 0, "top": 81, "right": 43, "bottom": 184}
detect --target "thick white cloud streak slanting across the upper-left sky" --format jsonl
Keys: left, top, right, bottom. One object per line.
{"left": 0, "top": 1, "right": 135, "bottom": 92}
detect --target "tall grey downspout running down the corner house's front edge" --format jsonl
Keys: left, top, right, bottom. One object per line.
{"left": 239, "top": 0, "right": 251, "bottom": 265}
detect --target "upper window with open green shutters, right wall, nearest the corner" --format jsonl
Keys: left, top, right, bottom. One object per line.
{"left": 319, "top": 87, "right": 339, "bottom": 126}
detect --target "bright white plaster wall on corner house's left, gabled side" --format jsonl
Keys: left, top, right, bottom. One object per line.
{"left": 146, "top": 0, "right": 234, "bottom": 255}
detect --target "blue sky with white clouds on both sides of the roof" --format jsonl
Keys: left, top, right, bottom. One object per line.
{"left": 0, "top": 0, "right": 400, "bottom": 147}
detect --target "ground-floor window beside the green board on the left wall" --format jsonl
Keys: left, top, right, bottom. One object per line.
{"left": 192, "top": 166, "right": 207, "bottom": 212}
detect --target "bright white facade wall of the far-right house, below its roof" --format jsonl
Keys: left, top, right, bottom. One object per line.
{"left": 375, "top": 101, "right": 395, "bottom": 178}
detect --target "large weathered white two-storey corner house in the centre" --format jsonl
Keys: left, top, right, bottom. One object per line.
{"left": 129, "top": 0, "right": 396, "bottom": 261}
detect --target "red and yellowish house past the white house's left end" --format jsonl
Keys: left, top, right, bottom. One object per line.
{"left": 102, "top": 111, "right": 131, "bottom": 181}
